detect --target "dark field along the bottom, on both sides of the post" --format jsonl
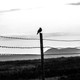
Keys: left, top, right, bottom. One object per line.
{"left": 0, "top": 57, "right": 80, "bottom": 80}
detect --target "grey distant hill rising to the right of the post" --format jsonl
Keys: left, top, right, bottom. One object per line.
{"left": 45, "top": 48, "right": 80, "bottom": 54}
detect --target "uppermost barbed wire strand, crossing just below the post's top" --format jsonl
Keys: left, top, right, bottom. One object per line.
{"left": 0, "top": 36, "right": 80, "bottom": 42}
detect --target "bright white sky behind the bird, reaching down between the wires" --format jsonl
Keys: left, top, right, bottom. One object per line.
{"left": 0, "top": 0, "right": 80, "bottom": 53}
